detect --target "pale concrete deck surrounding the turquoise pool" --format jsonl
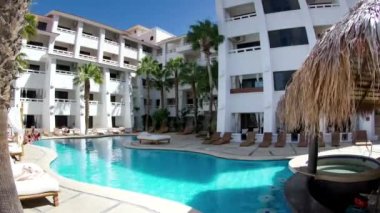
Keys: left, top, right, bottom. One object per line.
{"left": 22, "top": 134, "right": 380, "bottom": 213}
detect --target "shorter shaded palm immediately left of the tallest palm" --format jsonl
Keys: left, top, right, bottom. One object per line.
{"left": 179, "top": 62, "right": 204, "bottom": 132}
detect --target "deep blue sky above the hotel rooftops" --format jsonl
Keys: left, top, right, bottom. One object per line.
{"left": 31, "top": 0, "right": 216, "bottom": 35}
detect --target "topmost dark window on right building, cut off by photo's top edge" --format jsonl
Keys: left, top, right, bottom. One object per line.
{"left": 262, "top": 0, "right": 300, "bottom": 14}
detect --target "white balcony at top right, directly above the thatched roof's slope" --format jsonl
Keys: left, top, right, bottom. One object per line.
{"left": 307, "top": 0, "right": 346, "bottom": 25}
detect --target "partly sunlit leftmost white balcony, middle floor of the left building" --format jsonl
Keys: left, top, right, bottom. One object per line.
{"left": 16, "top": 69, "right": 45, "bottom": 89}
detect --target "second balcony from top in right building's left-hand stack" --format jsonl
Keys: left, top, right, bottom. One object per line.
{"left": 227, "top": 33, "right": 262, "bottom": 75}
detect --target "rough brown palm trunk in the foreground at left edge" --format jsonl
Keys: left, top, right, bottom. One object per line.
{"left": 0, "top": 0, "right": 29, "bottom": 212}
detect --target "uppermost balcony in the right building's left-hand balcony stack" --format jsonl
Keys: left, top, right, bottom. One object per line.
{"left": 225, "top": 3, "right": 259, "bottom": 37}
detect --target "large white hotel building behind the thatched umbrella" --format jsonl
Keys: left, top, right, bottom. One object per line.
{"left": 216, "top": 0, "right": 377, "bottom": 140}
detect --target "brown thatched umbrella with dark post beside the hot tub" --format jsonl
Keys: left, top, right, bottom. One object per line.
{"left": 283, "top": 0, "right": 380, "bottom": 173}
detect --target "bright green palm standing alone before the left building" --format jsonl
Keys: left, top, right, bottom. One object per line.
{"left": 73, "top": 63, "right": 103, "bottom": 134}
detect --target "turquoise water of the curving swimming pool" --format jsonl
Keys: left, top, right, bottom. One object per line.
{"left": 35, "top": 136, "right": 291, "bottom": 213}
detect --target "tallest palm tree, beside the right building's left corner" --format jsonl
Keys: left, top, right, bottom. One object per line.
{"left": 186, "top": 20, "right": 224, "bottom": 134}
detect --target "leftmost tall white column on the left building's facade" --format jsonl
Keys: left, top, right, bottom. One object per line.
{"left": 42, "top": 58, "right": 57, "bottom": 132}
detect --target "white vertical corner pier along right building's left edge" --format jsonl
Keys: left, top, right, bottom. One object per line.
{"left": 215, "top": 1, "right": 233, "bottom": 132}
